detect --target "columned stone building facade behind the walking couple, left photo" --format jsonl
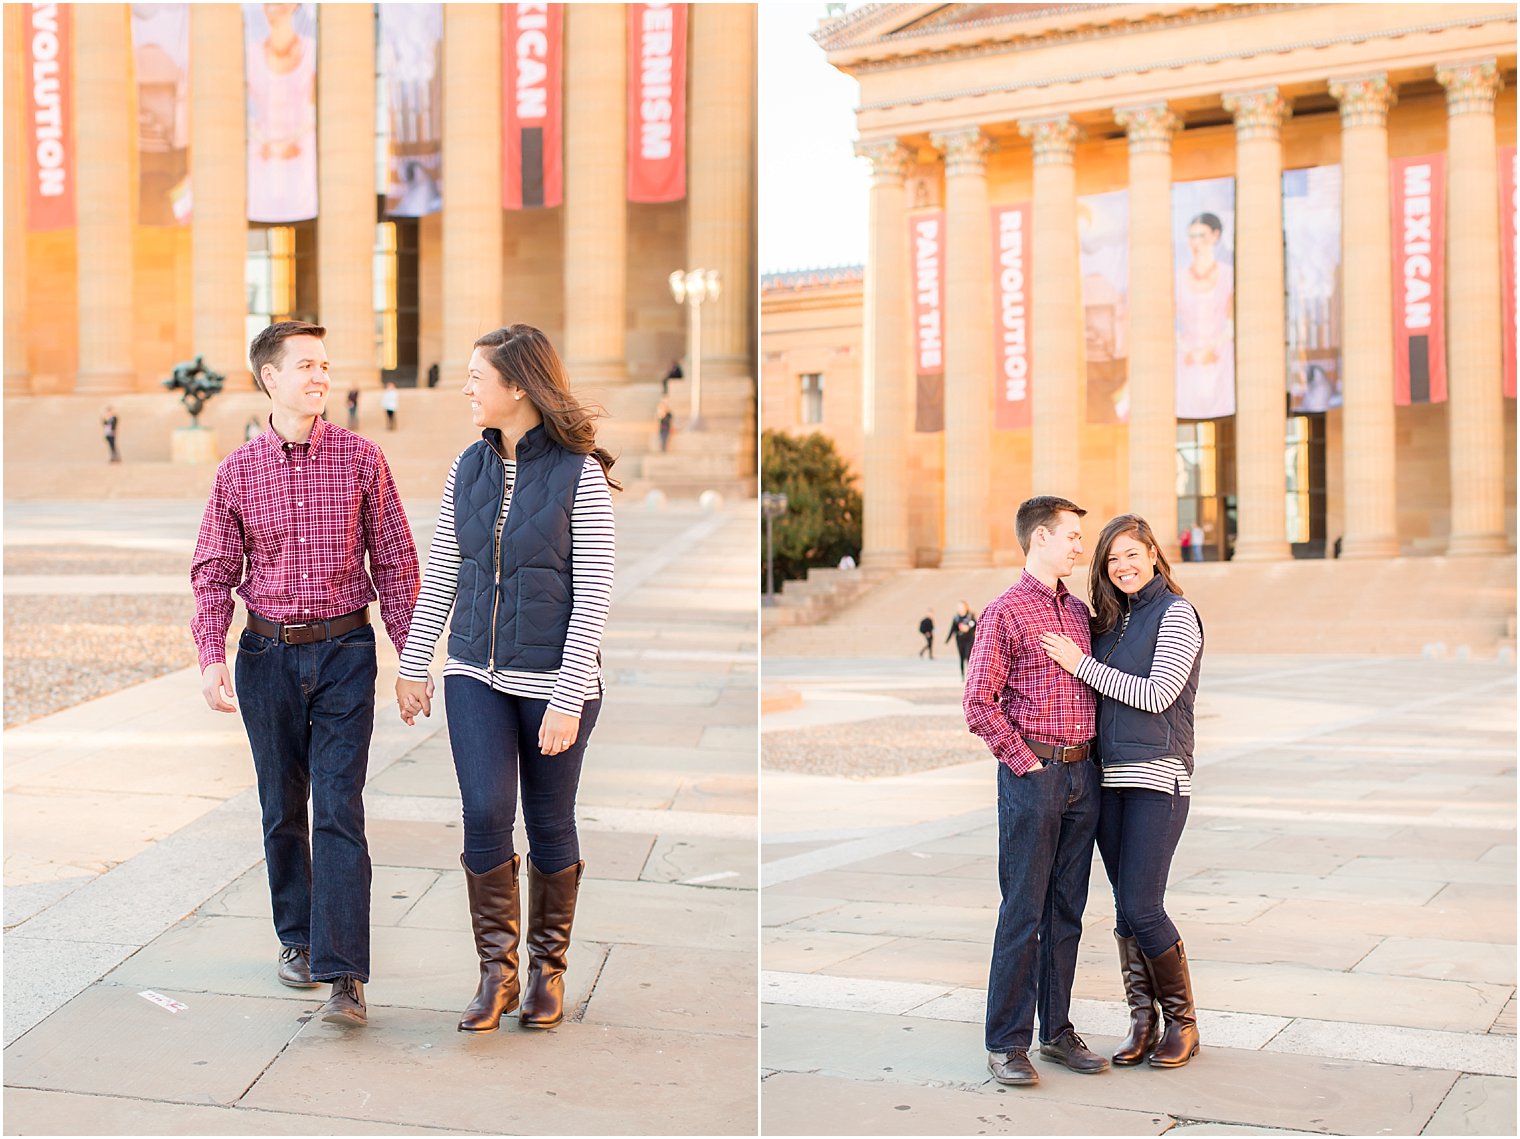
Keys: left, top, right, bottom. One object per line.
{"left": 5, "top": 3, "right": 755, "bottom": 483}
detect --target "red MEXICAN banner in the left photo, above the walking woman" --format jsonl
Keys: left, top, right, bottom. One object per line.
{"left": 502, "top": 5, "right": 564, "bottom": 210}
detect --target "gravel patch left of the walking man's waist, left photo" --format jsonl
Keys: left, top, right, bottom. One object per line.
{"left": 5, "top": 590, "right": 196, "bottom": 727}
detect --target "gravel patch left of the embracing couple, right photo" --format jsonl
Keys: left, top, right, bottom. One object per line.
{"left": 760, "top": 714, "right": 990, "bottom": 779}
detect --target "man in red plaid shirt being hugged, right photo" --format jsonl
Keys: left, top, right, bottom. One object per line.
{"left": 962, "top": 496, "right": 1108, "bottom": 1084}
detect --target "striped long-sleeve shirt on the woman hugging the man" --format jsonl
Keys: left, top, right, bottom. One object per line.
{"left": 1076, "top": 601, "right": 1204, "bottom": 795}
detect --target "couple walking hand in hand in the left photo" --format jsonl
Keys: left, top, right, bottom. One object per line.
{"left": 190, "top": 321, "right": 619, "bottom": 1033}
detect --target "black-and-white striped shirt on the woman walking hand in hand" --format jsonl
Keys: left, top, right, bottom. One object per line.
{"left": 401, "top": 455, "right": 616, "bottom": 716}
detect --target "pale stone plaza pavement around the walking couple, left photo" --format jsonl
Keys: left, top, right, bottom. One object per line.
{"left": 5, "top": 500, "right": 757, "bottom": 1134}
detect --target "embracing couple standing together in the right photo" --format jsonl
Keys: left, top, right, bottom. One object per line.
{"left": 962, "top": 496, "right": 1204, "bottom": 1084}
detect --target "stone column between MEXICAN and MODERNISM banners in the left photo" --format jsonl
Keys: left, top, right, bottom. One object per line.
{"left": 562, "top": 5, "right": 626, "bottom": 383}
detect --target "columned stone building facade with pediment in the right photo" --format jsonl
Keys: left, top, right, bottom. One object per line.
{"left": 762, "top": 3, "right": 1515, "bottom": 567}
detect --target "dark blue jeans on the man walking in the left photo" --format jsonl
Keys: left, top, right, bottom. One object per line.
{"left": 237, "top": 625, "right": 375, "bottom": 982}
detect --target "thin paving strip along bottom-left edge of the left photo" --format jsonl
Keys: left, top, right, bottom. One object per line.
{"left": 5, "top": 1087, "right": 477, "bottom": 1136}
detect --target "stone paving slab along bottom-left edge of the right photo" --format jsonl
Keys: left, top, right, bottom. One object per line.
{"left": 760, "top": 1072, "right": 1173, "bottom": 1136}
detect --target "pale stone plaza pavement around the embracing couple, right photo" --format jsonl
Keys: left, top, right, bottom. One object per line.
{"left": 760, "top": 649, "right": 1515, "bottom": 1136}
